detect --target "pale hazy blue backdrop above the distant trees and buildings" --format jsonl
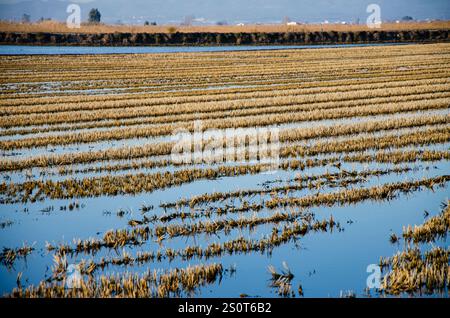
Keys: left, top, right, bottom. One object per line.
{"left": 0, "top": 0, "right": 450, "bottom": 24}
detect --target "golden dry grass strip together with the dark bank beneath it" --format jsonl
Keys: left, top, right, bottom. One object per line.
{"left": 0, "top": 22, "right": 449, "bottom": 46}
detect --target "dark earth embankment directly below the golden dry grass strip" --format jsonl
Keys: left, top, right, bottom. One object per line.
{"left": 0, "top": 29, "right": 450, "bottom": 46}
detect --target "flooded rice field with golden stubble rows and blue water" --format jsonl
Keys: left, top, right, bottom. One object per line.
{"left": 0, "top": 44, "right": 450, "bottom": 297}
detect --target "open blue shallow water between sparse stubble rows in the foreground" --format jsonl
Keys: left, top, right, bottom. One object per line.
{"left": 0, "top": 162, "right": 450, "bottom": 297}
